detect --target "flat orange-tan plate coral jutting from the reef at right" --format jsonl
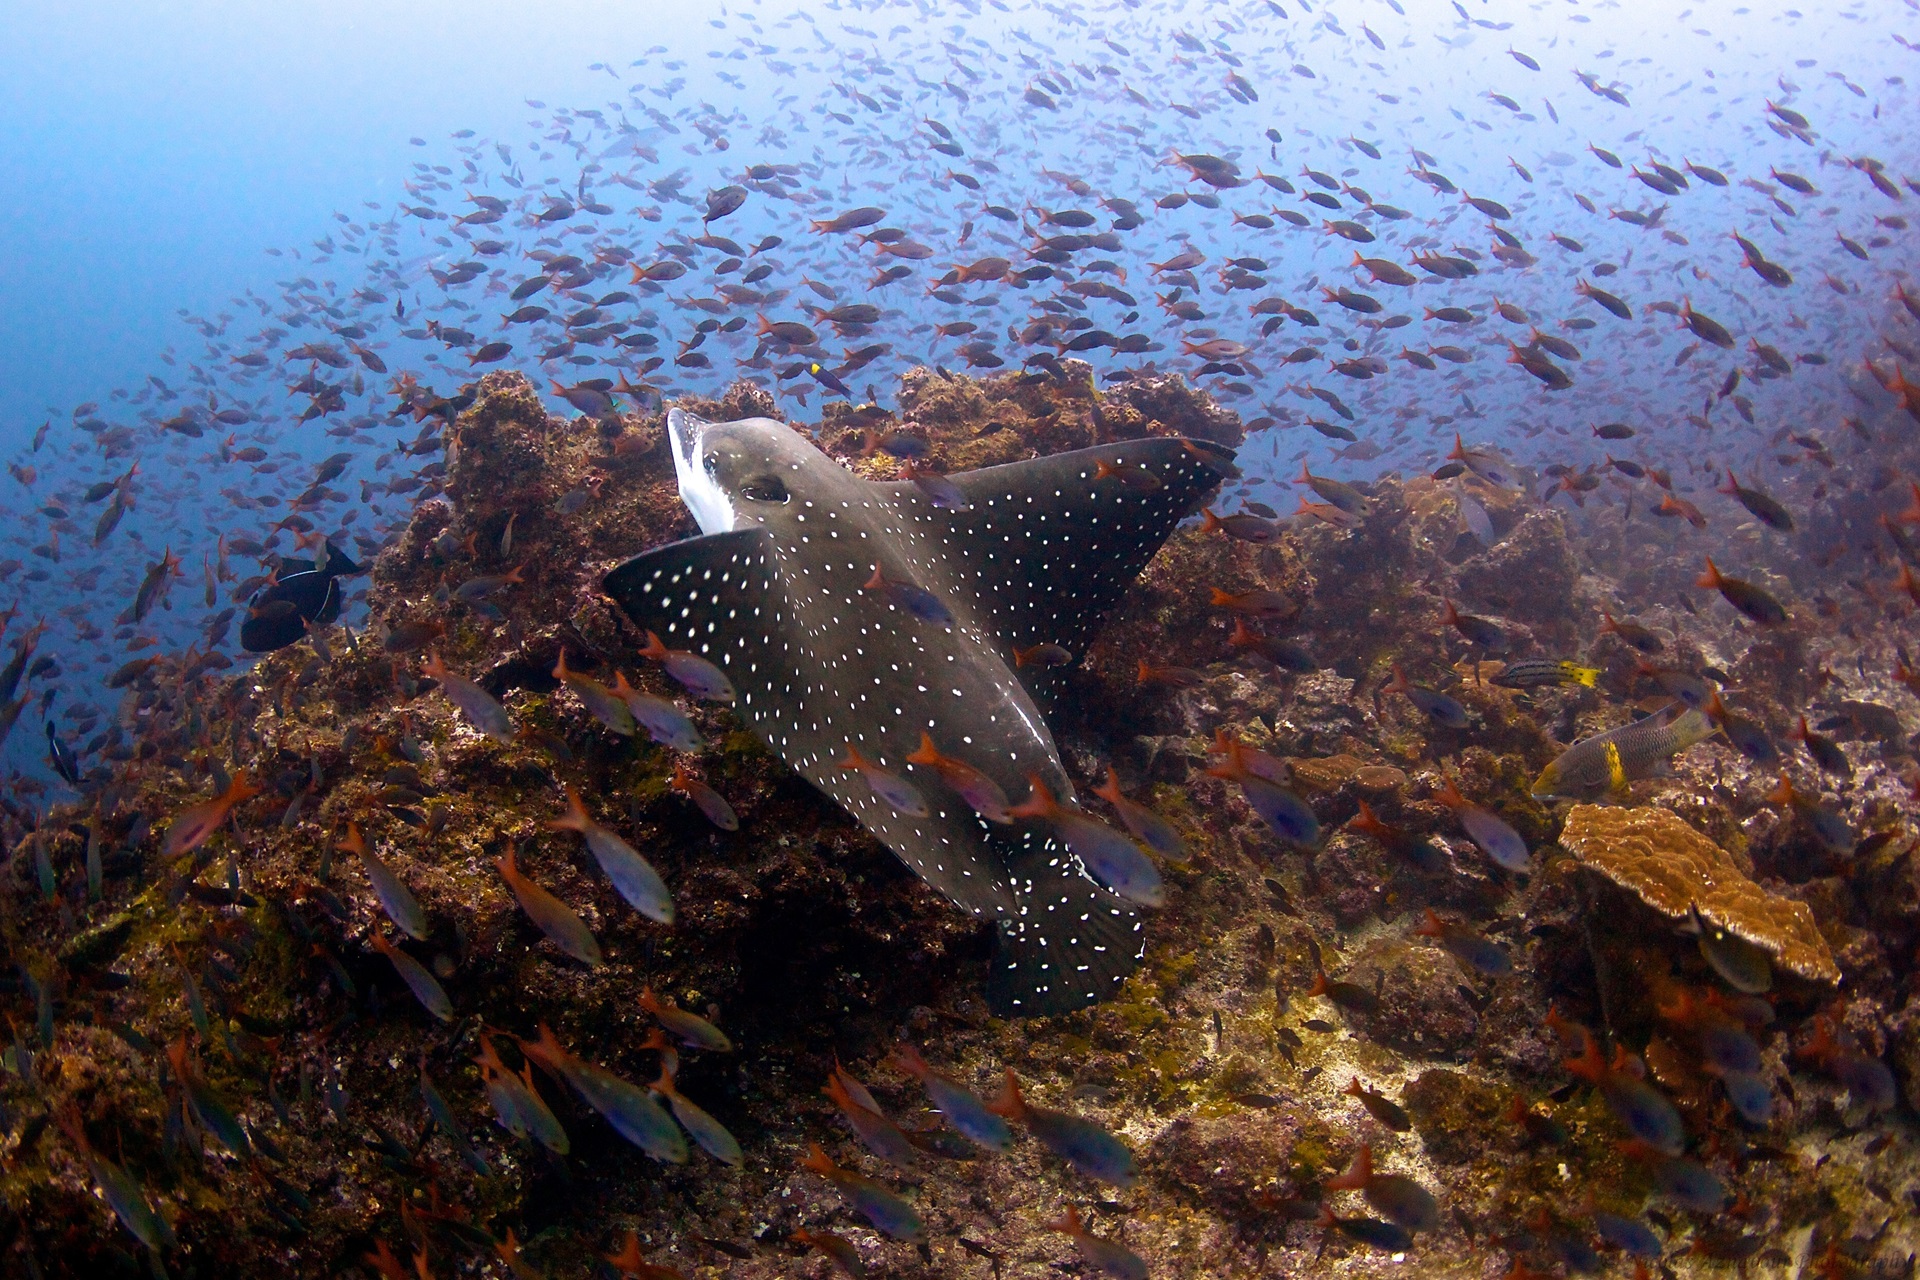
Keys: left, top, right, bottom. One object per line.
{"left": 1561, "top": 804, "right": 1839, "bottom": 983}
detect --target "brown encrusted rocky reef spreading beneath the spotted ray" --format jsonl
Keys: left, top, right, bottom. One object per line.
{"left": 4, "top": 363, "right": 1920, "bottom": 1278}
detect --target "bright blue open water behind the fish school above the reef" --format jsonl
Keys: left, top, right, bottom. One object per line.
{"left": 0, "top": 0, "right": 1920, "bottom": 782}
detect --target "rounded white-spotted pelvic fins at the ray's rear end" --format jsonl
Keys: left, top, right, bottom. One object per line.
{"left": 987, "top": 833, "right": 1146, "bottom": 1017}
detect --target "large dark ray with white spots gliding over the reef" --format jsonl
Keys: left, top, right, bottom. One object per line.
{"left": 603, "top": 409, "right": 1233, "bottom": 1015}
